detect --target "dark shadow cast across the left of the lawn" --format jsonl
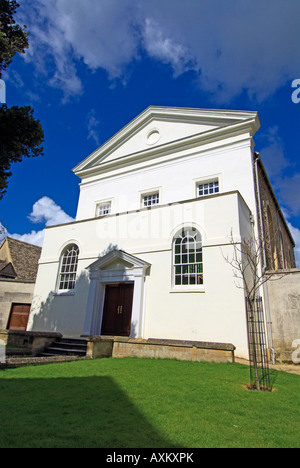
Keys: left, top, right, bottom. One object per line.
{"left": 0, "top": 376, "right": 175, "bottom": 448}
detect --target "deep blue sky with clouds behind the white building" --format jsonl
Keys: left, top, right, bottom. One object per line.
{"left": 0, "top": 0, "right": 300, "bottom": 265}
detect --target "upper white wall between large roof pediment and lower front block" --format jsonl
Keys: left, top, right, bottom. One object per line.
{"left": 76, "top": 135, "right": 256, "bottom": 224}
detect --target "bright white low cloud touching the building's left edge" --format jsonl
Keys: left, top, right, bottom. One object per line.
{"left": 0, "top": 197, "right": 74, "bottom": 246}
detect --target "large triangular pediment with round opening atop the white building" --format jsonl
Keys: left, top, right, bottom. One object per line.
{"left": 73, "top": 107, "right": 260, "bottom": 177}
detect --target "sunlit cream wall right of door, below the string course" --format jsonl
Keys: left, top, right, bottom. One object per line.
{"left": 144, "top": 247, "right": 247, "bottom": 357}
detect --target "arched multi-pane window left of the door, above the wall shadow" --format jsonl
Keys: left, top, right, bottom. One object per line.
{"left": 58, "top": 244, "right": 79, "bottom": 291}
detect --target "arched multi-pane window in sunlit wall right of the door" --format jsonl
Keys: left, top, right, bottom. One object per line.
{"left": 173, "top": 228, "right": 203, "bottom": 286}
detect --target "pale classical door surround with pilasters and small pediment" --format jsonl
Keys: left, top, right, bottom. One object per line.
{"left": 84, "top": 250, "right": 151, "bottom": 338}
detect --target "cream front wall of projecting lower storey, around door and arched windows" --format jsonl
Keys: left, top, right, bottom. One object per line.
{"left": 29, "top": 192, "right": 249, "bottom": 355}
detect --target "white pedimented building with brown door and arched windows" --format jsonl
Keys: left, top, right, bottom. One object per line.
{"left": 28, "top": 107, "right": 295, "bottom": 357}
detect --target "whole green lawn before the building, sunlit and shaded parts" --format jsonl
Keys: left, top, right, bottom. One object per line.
{"left": 0, "top": 358, "right": 300, "bottom": 448}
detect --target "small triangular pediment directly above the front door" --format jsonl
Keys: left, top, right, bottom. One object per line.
{"left": 87, "top": 250, "right": 151, "bottom": 272}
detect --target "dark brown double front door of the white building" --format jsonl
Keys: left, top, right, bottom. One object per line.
{"left": 101, "top": 283, "right": 134, "bottom": 336}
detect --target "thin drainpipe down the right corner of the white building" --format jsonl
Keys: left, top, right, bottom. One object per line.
{"left": 254, "top": 153, "right": 276, "bottom": 364}
